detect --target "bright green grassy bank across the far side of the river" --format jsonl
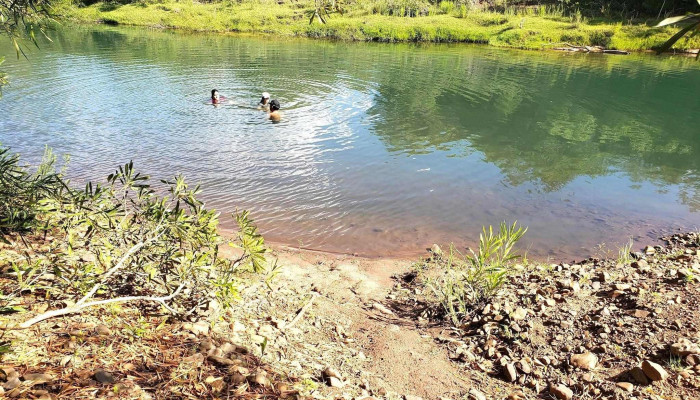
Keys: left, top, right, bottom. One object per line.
{"left": 56, "top": 0, "right": 700, "bottom": 51}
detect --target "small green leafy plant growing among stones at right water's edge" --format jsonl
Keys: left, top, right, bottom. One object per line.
{"left": 428, "top": 222, "right": 527, "bottom": 324}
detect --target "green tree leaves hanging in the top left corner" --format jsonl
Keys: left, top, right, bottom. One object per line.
{"left": 0, "top": 0, "right": 51, "bottom": 95}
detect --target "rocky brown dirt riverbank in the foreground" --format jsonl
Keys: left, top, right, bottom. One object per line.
{"left": 0, "top": 233, "right": 700, "bottom": 400}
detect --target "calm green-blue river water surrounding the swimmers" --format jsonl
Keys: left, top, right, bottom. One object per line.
{"left": 0, "top": 27, "right": 700, "bottom": 256}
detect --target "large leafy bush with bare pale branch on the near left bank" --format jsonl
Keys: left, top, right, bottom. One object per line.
{"left": 0, "top": 150, "right": 266, "bottom": 327}
